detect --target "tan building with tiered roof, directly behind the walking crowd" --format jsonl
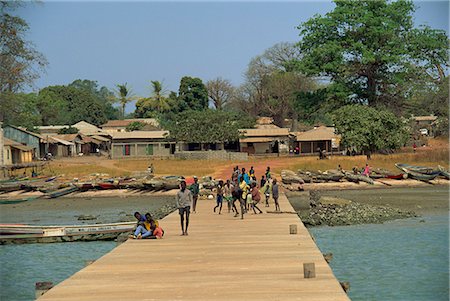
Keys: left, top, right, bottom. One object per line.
{"left": 239, "top": 124, "right": 289, "bottom": 155}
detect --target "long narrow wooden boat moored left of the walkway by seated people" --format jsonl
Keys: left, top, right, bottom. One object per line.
{"left": 0, "top": 222, "right": 136, "bottom": 245}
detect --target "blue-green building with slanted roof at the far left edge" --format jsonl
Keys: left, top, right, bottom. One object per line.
{"left": 3, "top": 125, "right": 45, "bottom": 159}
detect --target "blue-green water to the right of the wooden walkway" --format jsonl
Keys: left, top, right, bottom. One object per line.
{"left": 309, "top": 215, "right": 449, "bottom": 301}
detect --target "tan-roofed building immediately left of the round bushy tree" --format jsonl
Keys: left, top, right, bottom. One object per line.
{"left": 291, "top": 126, "right": 341, "bottom": 154}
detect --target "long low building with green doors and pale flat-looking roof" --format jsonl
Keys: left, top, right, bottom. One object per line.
{"left": 111, "top": 131, "right": 176, "bottom": 159}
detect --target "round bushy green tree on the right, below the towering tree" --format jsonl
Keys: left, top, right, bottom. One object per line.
{"left": 333, "top": 104, "right": 409, "bottom": 159}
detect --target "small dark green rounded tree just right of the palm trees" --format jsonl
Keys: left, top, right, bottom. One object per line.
{"left": 178, "top": 76, "right": 208, "bottom": 111}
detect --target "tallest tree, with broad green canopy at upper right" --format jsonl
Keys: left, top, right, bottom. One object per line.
{"left": 297, "top": 0, "right": 448, "bottom": 111}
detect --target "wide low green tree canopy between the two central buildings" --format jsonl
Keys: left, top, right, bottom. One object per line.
{"left": 161, "top": 109, "right": 255, "bottom": 143}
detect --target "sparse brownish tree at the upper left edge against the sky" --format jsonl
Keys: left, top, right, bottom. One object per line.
{"left": 0, "top": 1, "right": 47, "bottom": 92}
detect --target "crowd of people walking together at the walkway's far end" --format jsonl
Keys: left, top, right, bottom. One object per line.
{"left": 213, "top": 166, "right": 280, "bottom": 219}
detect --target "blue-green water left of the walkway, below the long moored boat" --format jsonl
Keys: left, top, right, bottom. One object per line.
{"left": 0, "top": 241, "right": 117, "bottom": 301}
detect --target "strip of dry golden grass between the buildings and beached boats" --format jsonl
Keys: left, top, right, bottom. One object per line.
{"left": 37, "top": 139, "right": 449, "bottom": 178}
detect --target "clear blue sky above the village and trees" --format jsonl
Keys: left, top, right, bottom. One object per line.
{"left": 18, "top": 1, "right": 449, "bottom": 112}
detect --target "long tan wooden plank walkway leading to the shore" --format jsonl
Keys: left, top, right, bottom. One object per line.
{"left": 39, "top": 194, "right": 349, "bottom": 301}
